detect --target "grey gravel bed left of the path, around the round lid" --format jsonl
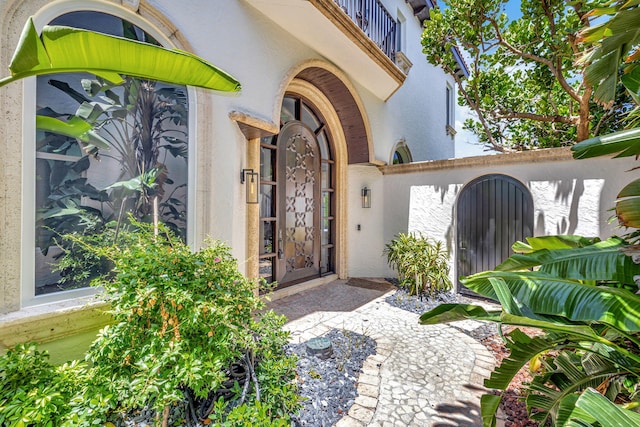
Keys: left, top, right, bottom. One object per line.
{"left": 288, "top": 329, "right": 376, "bottom": 427}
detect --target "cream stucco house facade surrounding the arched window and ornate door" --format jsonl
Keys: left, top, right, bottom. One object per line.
{"left": 0, "top": 0, "right": 480, "bottom": 354}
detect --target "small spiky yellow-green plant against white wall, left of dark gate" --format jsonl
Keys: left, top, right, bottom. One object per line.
{"left": 384, "top": 233, "right": 453, "bottom": 295}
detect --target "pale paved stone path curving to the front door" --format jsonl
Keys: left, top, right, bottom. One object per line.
{"left": 270, "top": 281, "right": 495, "bottom": 427}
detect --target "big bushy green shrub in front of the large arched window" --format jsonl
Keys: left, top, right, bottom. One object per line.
{"left": 81, "top": 223, "right": 297, "bottom": 426}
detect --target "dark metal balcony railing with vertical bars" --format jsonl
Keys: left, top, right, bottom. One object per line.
{"left": 334, "top": 0, "right": 396, "bottom": 61}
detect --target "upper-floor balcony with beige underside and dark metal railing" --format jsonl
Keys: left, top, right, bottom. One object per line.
{"left": 245, "top": 0, "right": 406, "bottom": 100}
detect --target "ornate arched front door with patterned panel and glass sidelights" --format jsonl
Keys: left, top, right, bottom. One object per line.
{"left": 259, "top": 93, "right": 336, "bottom": 288}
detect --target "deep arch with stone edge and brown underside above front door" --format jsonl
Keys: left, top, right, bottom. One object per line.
{"left": 273, "top": 60, "right": 374, "bottom": 164}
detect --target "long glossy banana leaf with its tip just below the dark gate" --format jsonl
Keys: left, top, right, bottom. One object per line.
{"left": 461, "top": 271, "right": 640, "bottom": 332}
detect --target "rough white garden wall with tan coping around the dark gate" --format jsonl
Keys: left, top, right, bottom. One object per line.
{"left": 379, "top": 149, "right": 635, "bottom": 279}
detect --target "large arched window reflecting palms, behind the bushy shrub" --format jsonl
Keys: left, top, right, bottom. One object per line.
{"left": 34, "top": 11, "right": 189, "bottom": 296}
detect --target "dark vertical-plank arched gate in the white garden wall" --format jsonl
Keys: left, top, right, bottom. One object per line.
{"left": 456, "top": 174, "right": 533, "bottom": 292}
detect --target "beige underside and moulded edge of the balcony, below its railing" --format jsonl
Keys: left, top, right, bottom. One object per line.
{"left": 245, "top": 0, "right": 406, "bottom": 100}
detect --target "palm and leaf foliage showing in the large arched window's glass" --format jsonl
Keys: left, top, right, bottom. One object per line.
{"left": 36, "top": 72, "right": 188, "bottom": 289}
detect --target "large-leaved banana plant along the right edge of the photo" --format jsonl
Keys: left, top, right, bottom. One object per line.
{"left": 420, "top": 1, "right": 640, "bottom": 427}
